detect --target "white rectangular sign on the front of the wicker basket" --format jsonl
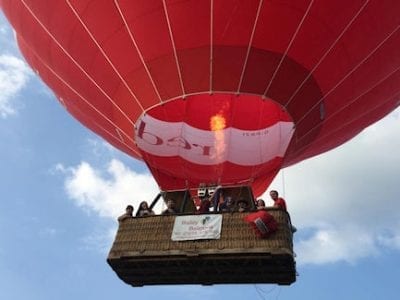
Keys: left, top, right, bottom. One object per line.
{"left": 171, "top": 214, "right": 222, "bottom": 241}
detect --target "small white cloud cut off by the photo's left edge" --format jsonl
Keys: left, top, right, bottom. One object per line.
{"left": 0, "top": 54, "right": 32, "bottom": 118}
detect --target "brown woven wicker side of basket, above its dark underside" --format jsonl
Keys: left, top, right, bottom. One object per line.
{"left": 109, "top": 209, "right": 293, "bottom": 258}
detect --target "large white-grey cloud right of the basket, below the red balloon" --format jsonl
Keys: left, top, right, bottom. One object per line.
{"left": 264, "top": 109, "right": 400, "bottom": 264}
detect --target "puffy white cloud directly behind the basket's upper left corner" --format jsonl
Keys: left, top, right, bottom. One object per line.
{"left": 60, "top": 159, "right": 158, "bottom": 218}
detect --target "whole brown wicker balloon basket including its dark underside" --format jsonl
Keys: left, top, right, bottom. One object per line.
{"left": 107, "top": 209, "right": 296, "bottom": 286}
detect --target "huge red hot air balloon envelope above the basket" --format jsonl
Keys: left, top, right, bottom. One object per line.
{"left": 0, "top": 0, "right": 400, "bottom": 194}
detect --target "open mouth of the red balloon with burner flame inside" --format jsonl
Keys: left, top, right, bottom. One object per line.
{"left": 135, "top": 94, "right": 294, "bottom": 189}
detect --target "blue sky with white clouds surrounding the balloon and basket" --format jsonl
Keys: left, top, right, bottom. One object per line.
{"left": 0, "top": 12, "right": 400, "bottom": 300}
